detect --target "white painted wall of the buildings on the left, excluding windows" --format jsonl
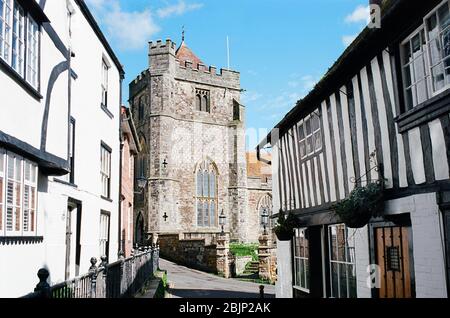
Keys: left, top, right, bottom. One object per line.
{"left": 0, "top": 0, "right": 121, "bottom": 298}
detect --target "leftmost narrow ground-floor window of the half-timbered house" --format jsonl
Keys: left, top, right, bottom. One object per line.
{"left": 294, "top": 229, "right": 310, "bottom": 293}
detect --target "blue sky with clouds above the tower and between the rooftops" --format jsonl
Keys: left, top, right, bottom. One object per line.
{"left": 86, "top": 0, "right": 369, "bottom": 148}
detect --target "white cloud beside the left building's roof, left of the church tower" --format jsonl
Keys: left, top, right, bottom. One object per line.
{"left": 87, "top": 0, "right": 160, "bottom": 50}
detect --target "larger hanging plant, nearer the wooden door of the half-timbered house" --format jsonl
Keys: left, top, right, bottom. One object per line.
{"left": 333, "top": 182, "right": 384, "bottom": 228}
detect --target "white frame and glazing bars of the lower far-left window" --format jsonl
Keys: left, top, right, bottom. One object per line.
{"left": 0, "top": 149, "right": 38, "bottom": 237}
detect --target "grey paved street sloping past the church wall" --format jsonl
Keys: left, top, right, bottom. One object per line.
{"left": 160, "top": 259, "right": 275, "bottom": 298}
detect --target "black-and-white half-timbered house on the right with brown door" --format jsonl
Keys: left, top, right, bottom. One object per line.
{"left": 258, "top": 0, "right": 450, "bottom": 298}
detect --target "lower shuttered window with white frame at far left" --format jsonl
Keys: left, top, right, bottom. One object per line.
{"left": 0, "top": 149, "right": 38, "bottom": 237}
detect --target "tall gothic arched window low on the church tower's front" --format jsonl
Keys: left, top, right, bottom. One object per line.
{"left": 196, "top": 160, "right": 218, "bottom": 227}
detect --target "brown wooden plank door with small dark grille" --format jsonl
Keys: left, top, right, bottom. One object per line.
{"left": 375, "top": 227, "right": 413, "bottom": 298}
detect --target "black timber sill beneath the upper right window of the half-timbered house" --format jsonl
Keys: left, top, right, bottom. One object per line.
{"left": 395, "top": 88, "right": 450, "bottom": 133}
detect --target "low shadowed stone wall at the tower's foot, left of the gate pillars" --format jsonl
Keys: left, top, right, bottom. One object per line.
{"left": 159, "top": 234, "right": 217, "bottom": 273}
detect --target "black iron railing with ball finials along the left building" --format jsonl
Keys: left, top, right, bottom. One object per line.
{"left": 22, "top": 246, "right": 159, "bottom": 298}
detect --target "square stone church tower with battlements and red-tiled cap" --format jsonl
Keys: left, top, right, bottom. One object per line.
{"left": 130, "top": 40, "right": 256, "bottom": 242}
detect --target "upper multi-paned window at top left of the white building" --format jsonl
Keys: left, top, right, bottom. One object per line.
{"left": 0, "top": 0, "right": 40, "bottom": 89}
